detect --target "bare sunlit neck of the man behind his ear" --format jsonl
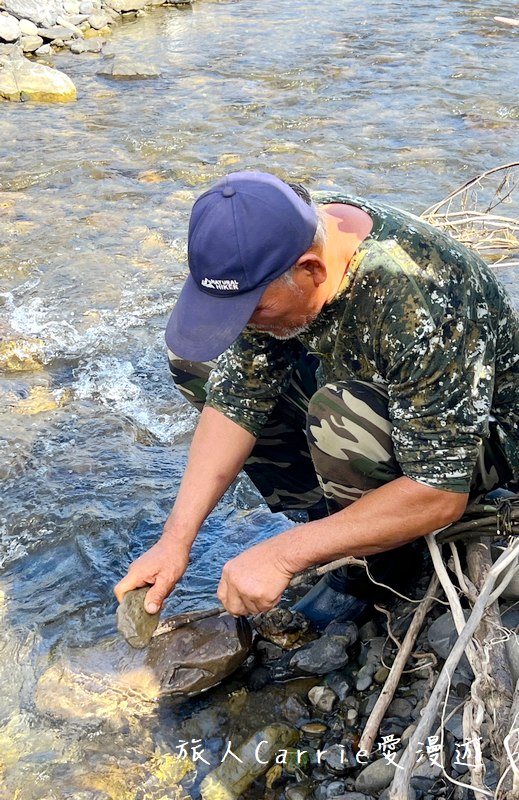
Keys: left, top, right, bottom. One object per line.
{"left": 321, "top": 203, "right": 373, "bottom": 303}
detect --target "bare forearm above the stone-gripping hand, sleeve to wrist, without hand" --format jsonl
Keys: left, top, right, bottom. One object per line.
{"left": 163, "top": 407, "right": 256, "bottom": 547}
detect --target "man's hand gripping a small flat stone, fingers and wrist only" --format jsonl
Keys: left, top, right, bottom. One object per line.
{"left": 114, "top": 539, "right": 189, "bottom": 614}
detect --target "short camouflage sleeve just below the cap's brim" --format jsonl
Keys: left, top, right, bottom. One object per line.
{"left": 206, "top": 328, "right": 298, "bottom": 436}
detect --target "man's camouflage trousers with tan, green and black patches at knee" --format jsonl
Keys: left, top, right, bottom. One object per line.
{"left": 169, "top": 349, "right": 509, "bottom": 519}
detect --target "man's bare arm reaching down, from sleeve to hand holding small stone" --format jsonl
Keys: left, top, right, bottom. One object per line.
{"left": 114, "top": 407, "right": 256, "bottom": 613}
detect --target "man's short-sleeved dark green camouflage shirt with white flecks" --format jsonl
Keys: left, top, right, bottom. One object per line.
{"left": 207, "top": 195, "right": 519, "bottom": 492}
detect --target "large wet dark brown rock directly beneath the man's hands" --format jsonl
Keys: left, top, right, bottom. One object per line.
{"left": 146, "top": 614, "right": 252, "bottom": 696}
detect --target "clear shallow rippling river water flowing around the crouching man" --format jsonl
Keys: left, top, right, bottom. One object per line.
{"left": 0, "top": 0, "right": 519, "bottom": 800}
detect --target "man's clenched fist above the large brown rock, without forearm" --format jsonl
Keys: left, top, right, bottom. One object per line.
{"left": 218, "top": 538, "right": 293, "bottom": 616}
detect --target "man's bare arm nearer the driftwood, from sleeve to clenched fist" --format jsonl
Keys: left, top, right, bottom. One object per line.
{"left": 218, "top": 477, "right": 468, "bottom": 614}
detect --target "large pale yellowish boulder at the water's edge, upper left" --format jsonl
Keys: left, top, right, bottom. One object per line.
{"left": 0, "top": 48, "right": 77, "bottom": 103}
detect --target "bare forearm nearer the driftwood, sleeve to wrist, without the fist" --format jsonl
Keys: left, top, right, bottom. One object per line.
{"left": 272, "top": 477, "right": 468, "bottom": 573}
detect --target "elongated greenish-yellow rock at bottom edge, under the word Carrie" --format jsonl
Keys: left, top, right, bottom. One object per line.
{"left": 200, "top": 722, "right": 299, "bottom": 800}
